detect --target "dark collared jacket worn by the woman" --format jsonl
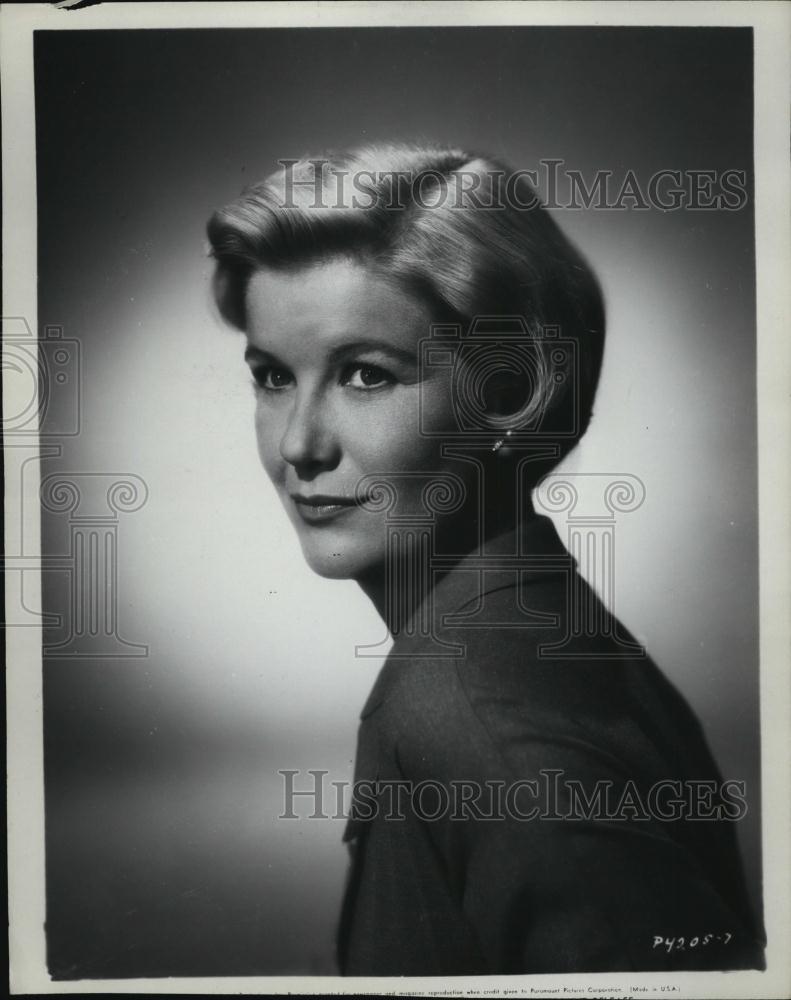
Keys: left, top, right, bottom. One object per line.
{"left": 338, "top": 517, "right": 764, "bottom": 975}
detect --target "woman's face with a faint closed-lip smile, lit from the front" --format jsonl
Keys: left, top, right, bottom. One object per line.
{"left": 246, "top": 260, "right": 470, "bottom": 579}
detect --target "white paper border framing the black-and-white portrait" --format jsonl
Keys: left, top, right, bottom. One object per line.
{"left": 6, "top": 2, "right": 791, "bottom": 998}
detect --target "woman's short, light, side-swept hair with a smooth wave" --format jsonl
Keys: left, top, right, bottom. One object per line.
{"left": 208, "top": 144, "right": 605, "bottom": 465}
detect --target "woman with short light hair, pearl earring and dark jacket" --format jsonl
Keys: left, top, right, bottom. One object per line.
{"left": 209, "top": 146, "right": 763, "bottom": 975}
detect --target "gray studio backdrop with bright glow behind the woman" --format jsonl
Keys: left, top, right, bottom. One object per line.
{"left": 36, "top": 28, "right": 760, "bottom": 978}
